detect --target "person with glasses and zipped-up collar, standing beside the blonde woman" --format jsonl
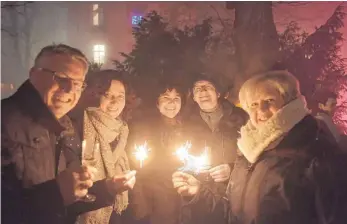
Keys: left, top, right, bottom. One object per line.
{"left": 182, "top": 75, "right": 248, "bottom": 224}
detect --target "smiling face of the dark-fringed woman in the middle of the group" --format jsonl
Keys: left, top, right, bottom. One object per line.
{"left": 157, "top": 89, "right": 182, "bottom": 118}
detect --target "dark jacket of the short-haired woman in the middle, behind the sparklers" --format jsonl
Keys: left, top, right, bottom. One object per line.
{"left": 128, "top": 115, "right": 190, "bottom": 224}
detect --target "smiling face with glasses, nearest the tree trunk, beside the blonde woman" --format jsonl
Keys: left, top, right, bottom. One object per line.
{"left": 193, "top": 80, "right": 220, "bottom": 112}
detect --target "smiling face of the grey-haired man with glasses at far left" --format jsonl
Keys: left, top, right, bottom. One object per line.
{"left": 30, "top": 54, "right": 86, "bottom": 119}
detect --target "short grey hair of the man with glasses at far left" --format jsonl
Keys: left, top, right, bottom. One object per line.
{"left": 35, "top": 44, "right": 89, "bottom": 73}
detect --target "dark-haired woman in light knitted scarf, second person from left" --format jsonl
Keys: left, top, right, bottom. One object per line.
{"left": 77, "top": 70, "right": 135, "bottom": 224}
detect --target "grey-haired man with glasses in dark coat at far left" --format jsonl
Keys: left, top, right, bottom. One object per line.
{"left": 1, "top": 44, "right": 135, "bottom": 224}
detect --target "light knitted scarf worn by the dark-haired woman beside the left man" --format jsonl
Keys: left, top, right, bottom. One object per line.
{"left": 80, "top": 108, "right": 129, "bottom": 224}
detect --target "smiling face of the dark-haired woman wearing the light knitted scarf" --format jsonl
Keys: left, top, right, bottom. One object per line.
{"left": 100, "top": 80, "right": 125, "bottom": 118}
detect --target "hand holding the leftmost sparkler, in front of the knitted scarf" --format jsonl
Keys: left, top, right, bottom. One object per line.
{"left": 106, "top": 170, "right": 136, "bottom": 195}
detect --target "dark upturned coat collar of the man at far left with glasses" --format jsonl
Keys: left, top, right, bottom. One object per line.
{"left": 13, "top": 80, "right": 68, "bottom": 135}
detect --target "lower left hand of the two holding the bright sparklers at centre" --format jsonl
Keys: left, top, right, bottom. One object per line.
{"left": 172, "top": 171, "right": 200, "bottom": 196}
